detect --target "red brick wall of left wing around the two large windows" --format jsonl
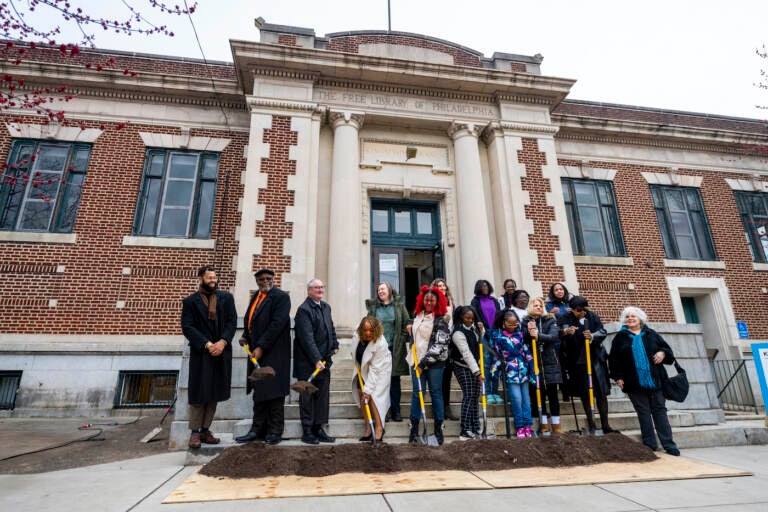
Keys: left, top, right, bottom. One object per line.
{"left": 0, "top": 119, "right": 247, "bottom": 335}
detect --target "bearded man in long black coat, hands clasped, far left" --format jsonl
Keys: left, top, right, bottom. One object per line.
{"left": 181, "top": 265, "right": 237, "bottom": 448}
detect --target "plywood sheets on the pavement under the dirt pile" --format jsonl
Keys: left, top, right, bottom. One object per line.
{"left": 163, "top": 455, "right": 751, "bottom": 503}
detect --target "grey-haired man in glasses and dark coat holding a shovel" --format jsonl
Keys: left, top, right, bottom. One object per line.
{"left": 293, "top": 279, "right": 339, "bottom": 444}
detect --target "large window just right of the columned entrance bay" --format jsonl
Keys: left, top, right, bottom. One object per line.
{"left": 562, "top": 178, "right": 625, "bottom": 256}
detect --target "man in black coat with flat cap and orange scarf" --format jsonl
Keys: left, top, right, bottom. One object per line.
{"left": 235, "top": 268, "right": 291, "bottom": 444}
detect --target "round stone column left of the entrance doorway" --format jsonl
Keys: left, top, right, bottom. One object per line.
{"left": 326, "top": 112, "right": 363, "bottom": 331}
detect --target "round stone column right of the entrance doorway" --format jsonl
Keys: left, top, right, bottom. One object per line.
{"left": 448, "top": 123, "right": 497, "bottom": 304}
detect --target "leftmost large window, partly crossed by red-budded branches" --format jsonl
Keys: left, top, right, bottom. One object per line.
{"left": 0, "top": 140, "right": 91, "bottom": 233}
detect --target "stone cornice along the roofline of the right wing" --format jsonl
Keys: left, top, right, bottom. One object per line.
{"left": 552, "top": 114, "right": 768, "bottom": 153}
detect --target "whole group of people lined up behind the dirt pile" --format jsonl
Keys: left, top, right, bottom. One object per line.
{"left": 182, "top": 267, "right": 679, "bottom": 455}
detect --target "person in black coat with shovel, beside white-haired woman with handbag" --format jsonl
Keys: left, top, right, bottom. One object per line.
{"left": 557, "top": 295, "right": 616, "bottom": 434}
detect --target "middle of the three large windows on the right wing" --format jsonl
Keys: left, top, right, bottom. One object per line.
{"left": 651, "top": 185, "right": 717, "bottom": 261}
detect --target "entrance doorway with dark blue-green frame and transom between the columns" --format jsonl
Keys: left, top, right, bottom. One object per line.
{"left": 371, "top": 199, "right": 445, "bottom": 312}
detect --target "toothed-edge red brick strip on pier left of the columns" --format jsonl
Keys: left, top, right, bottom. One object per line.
{"left": 253, "top": 116, "right": 298, "bottom": 286}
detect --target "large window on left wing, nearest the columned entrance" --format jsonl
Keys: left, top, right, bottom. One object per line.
{"left": 133, "top": 149, "right": 219, "bottom": 238}
